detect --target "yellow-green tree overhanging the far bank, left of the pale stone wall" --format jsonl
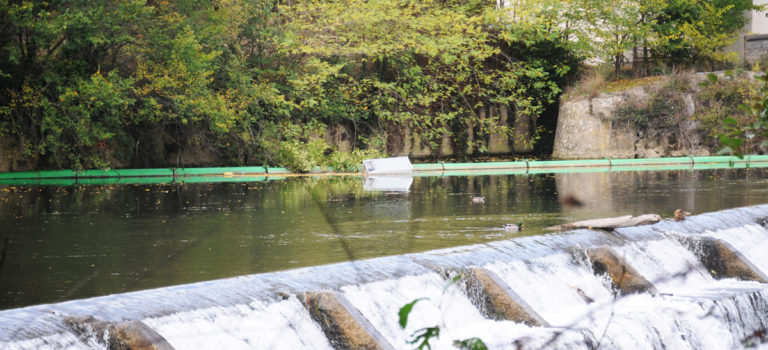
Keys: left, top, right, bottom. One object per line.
{"left": 283, "top": 0, "right": 577, "bottom": 154}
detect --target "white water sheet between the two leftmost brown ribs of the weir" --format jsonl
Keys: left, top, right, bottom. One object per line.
{"left": 143, "top": 297, "right": 332, "bottom": 350}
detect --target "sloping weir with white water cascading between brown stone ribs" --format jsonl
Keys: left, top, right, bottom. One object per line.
{"left": 0, "top": 205, "right": 768, "bottom": 349}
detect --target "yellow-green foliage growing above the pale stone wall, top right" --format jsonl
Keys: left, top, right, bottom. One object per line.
{"left": 562, "top": 0, "right": 759, "bottom": 75}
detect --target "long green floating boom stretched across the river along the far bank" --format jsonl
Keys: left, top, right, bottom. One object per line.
{"left": 0, "top": 155, "right": 768, "bottom": 185}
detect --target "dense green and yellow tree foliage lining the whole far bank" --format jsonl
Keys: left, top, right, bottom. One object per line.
{"left": 0, "top": 0, "right": 752, "bottom": 171}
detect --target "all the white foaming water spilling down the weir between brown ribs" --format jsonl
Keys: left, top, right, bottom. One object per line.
{"left": 0, "top": 208, "right": 768, "bottom": 350}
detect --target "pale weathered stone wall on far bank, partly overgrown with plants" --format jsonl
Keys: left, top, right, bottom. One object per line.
{"left": 552, "top": 87, "right": 709, "bottom": 159}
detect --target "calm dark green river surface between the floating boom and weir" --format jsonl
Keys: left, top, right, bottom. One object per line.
{"left": 0, "top": 169, "right": 768, "bottom": 309}
